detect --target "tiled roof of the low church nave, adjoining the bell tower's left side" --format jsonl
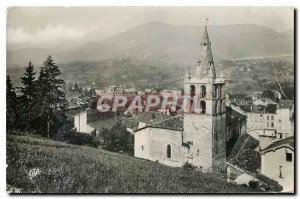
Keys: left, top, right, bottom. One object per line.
{"left": 150, "top": 116, "right": 183, "bottom": 131}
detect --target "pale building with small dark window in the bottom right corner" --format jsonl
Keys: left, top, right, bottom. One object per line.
{"left": 261, "top": 137, "right": 295, "bottom": 192}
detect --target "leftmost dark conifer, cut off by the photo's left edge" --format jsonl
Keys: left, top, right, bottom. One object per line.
{"left": 6, "top": 75, "right": 18, "bottom": 131}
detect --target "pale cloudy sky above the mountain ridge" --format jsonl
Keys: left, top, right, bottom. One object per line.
{"left": 7, "top": 7, "right": 294, "bottom": 49}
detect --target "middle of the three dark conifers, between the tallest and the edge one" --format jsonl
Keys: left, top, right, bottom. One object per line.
{"left": 20, "top": 62, "right": 36, "bottom": 129}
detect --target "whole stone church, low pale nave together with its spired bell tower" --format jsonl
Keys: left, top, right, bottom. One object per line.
{"left": 134, "top": 23, "right": 226, "bottom": 172}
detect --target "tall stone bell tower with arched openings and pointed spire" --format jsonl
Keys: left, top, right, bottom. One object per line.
{"left": 183, "top": 19, "right": 226, "bottom": 172}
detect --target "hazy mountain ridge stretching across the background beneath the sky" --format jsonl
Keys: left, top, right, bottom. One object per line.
{"left": 7, "top": 22, "right": 294, "bottom": 68}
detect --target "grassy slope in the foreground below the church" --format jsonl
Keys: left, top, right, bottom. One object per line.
{"left": 7, "top": 136, "right": 253, "bottom": 193}
